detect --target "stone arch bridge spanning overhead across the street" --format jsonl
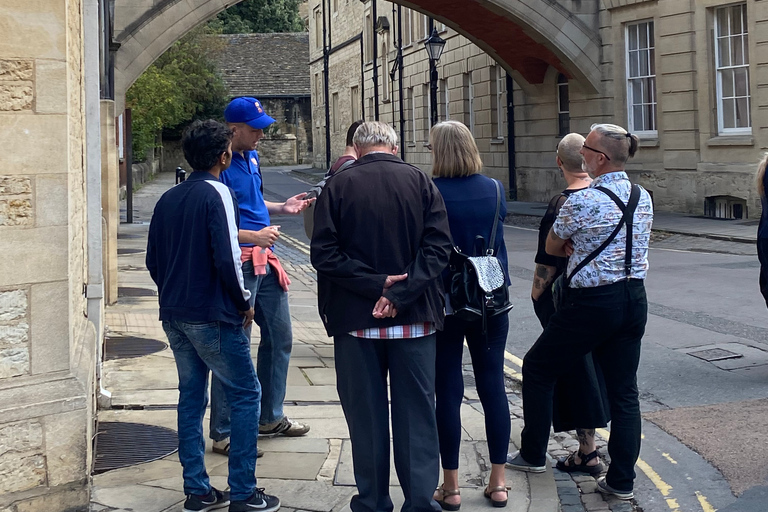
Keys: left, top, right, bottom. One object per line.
{"left": 115, "top": 0, "right": 600, "bottom": 98}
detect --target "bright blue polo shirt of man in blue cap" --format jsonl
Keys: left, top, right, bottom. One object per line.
{"left": 220, "top": 151, "right": 269, "bottom": 247}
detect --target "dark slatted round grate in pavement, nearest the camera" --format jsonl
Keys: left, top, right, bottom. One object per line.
{"left": 93, "top": 421, "right": 179, "bottom": 474}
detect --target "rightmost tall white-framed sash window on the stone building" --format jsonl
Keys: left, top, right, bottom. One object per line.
{"left": 715, "top": 4, "right": 752, "bottom": 135}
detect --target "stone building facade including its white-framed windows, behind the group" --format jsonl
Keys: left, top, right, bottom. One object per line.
{"left": 309, "top": 0, "right": 768, "bottom": 218}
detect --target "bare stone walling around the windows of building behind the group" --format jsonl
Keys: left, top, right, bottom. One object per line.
{"left": 309, "top": 0, "right": 768, "bottom": 217}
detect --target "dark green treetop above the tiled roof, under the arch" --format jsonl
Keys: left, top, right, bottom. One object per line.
{"left": 208, "top": 0, "right": 304, "bottom": 34}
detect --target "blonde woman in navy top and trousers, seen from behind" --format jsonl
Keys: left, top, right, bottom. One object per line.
{"left": 429, "top": 121, "right": 510, "bottom": 511}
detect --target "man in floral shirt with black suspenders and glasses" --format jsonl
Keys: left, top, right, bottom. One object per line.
{"left": 507, "top": 124, "right": 653, "bottom": 500}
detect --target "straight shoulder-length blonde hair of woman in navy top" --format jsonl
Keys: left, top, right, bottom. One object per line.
{"left": 429, "top": 121, "right": 483, "bottom": 178}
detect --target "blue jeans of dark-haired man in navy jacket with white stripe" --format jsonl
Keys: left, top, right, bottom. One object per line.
{"left": 163, "top": 320, "right": 261, "bottom": 500}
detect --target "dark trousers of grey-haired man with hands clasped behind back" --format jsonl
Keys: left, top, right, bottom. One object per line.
{"left": 334, "top": 334, "right": 440, "bottom": 512}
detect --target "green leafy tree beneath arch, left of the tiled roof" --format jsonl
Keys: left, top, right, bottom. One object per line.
{"left": 125, "top": 27, "right": 228, "bottom": 161}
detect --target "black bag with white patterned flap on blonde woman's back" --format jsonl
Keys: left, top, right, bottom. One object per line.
{"left": 448, "top": 180, "right": 512, "bottom": 326}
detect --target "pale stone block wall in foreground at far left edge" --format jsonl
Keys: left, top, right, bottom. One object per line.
{"left": 0, "top": 0, "right": 92, "bottom": 512}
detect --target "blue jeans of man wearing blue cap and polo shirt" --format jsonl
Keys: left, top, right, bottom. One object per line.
{"left": 211, "top": 261, "right": 293, "bottom": 441}
